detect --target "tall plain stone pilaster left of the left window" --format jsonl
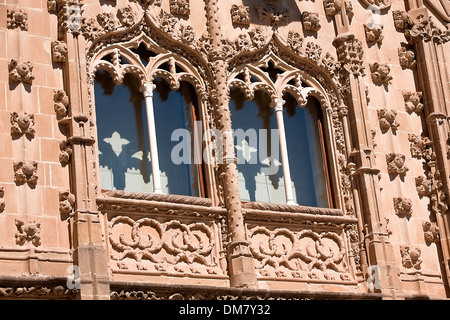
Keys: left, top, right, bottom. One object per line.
{"left": 60, "top": 5, "right": 109, "bottom": 300}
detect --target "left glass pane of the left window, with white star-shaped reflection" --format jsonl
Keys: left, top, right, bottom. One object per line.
{"left": 94, "top": 71, "right": 153, "bottom": 192}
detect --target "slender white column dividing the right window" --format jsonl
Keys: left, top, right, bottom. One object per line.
{"left": 275, "top": 99, "right": 296, "bottom": 205}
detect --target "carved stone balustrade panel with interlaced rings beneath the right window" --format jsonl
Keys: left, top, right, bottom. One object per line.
{"left": 246, "top": 204, "right": 359, "bottom": 284}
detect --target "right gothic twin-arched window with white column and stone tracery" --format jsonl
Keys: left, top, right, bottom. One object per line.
{"left": 230, "top": 57, "right": 333, "bottom": 208}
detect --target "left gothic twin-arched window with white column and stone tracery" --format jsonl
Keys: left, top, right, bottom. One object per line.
{"left": 94, "top": 41, "right": 206, "bottom": 197}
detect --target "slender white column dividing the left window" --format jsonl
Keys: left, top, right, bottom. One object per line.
{"left": 143, "top": 83, "right": 163, "bottom": 194}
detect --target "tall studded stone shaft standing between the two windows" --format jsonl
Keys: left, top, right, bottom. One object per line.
{"left": 205, "top": 0, "right": 257, "bottom": 288}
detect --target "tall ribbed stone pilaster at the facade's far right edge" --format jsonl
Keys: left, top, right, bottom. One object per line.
{"left": 408, "top": 4, "right": 450, "bottom": 287}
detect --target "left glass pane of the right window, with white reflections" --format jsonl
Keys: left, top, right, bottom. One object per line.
{"left": 230, "top": 89, "right": 286, "bottom": 203}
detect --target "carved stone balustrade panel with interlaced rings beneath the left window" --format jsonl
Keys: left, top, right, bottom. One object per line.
{"left": 99, "top": 192, "right": 227, "bottom": 278}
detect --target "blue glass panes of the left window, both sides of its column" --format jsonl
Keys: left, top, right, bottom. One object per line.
{"left": 94, "top": 70, "right": 206, "bottom": 197}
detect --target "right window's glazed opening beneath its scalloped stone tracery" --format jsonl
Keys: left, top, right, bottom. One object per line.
{"left": 230, "top": 87, "right": 333, "bottom": 208}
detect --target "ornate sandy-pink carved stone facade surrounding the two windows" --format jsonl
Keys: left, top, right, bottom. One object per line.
{"left": 0, "top": 0, "right": 450, "bottom": 299}
